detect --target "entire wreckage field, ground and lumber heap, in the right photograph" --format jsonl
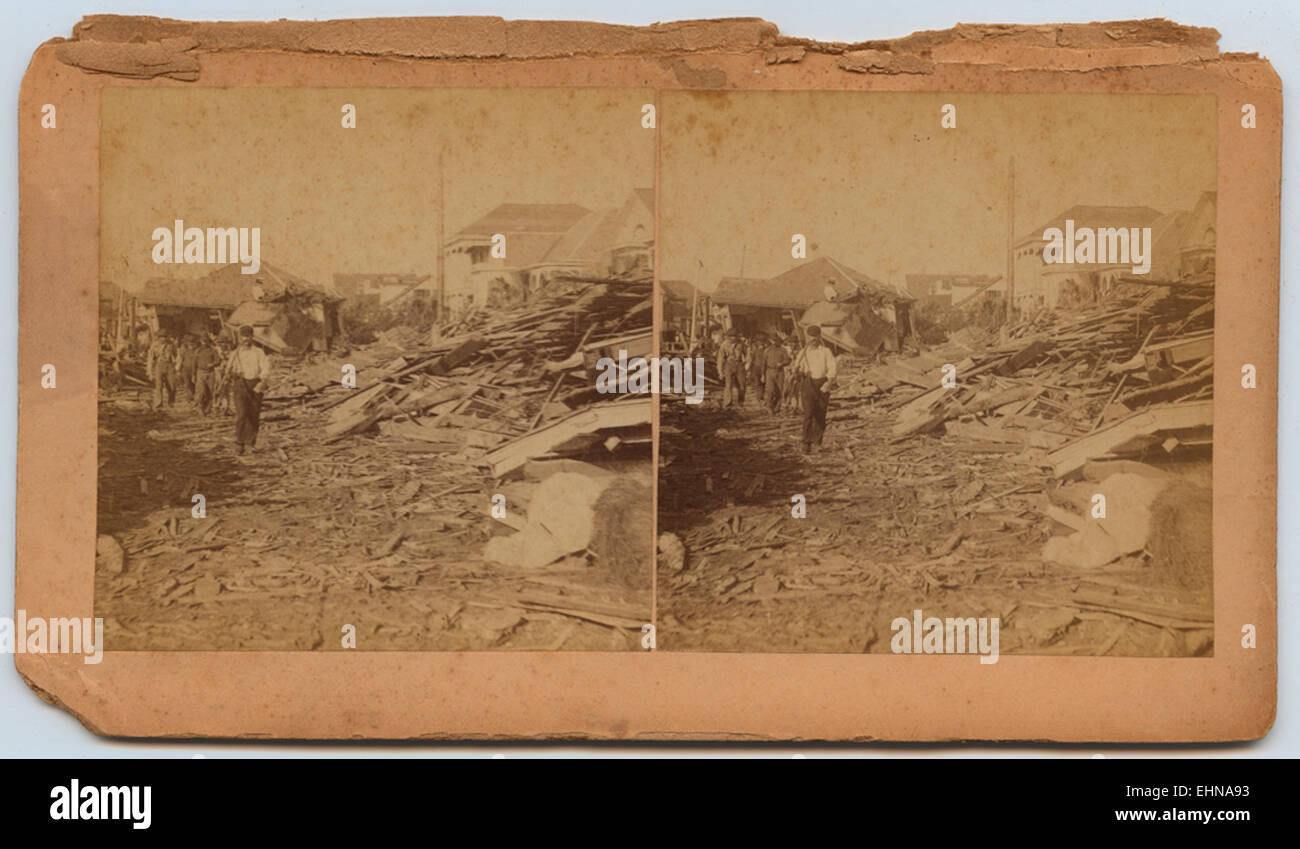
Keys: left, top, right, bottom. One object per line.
{"left": 658, "top": 286, "right": 1213, "bottom": 657}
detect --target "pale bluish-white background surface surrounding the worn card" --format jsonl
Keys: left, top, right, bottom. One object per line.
{"left": 0, "top": 0, "right": 1300, "bottom": 758}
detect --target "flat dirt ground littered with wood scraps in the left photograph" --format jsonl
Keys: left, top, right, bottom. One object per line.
{"left": 95, "top": 390, "right": 650, "bottom": 651}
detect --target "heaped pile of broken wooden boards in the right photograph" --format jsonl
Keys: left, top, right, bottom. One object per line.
{"left": 849, "top": 283, "right": 1214, "bottom": 477}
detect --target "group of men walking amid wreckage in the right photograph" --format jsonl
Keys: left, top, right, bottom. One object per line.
{"left": 716, "top": 325, "right": 836, "bottom": 454}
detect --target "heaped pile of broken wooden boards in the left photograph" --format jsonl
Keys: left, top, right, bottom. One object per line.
{"left": 268, "top": 274, "right": 653, "bottom": 477}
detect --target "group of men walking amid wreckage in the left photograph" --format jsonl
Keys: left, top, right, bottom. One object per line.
{"left": 146, "top": 325, "right": 270, "bottom": 454}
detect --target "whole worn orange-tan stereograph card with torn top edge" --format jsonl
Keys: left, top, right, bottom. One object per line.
{"left": 15, "top": 16, "right": 1282, "bottom": 742}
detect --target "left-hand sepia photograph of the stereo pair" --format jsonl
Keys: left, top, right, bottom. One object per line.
{"left": 95, "top": 87, "right": 655, "bottom": 651}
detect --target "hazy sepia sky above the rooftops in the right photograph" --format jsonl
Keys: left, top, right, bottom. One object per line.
{"left": 659, "top": 92, "right": 1217, "bottom": 290}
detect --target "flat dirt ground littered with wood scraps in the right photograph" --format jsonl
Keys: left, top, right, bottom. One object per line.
{"left": 658, "top": 364, "right": 1213, "bottom": 657}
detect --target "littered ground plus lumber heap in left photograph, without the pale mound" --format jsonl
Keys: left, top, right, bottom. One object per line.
{"left": 95, "top": 276, "right": 654, "bottom": 650}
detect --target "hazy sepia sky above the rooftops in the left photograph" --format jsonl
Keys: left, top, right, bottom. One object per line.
{"left": 100, "top": 87, "right": 654, "bottom": 289}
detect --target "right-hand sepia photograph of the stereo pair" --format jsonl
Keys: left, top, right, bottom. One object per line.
{"left": 657, "top": 91, "right": 1217, "bottom": 662}
